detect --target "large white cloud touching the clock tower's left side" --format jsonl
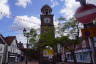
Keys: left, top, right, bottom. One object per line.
{"left": 11, "top": 16, "right": 40, "bottom": 30}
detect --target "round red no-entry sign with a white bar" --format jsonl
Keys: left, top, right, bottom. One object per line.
{"left": 75, "top": 4, "right": 96, "bottom": 24}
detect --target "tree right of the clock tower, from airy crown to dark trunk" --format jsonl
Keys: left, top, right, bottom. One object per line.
{"left": 59, "top": 18, "right": 80, "bottom": 64}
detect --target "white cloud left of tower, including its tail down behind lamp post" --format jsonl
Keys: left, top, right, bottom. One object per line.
{"left": 11, "top": 16, "right": 40, "bottom": 43}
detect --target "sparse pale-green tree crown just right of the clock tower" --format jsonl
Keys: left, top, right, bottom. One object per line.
{"left": 58, "top": 18, "right": 81, "bottom": 36}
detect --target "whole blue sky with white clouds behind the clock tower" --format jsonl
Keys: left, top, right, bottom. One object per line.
{"left": 0, "top": 0, "right": 96, "bottom": 43}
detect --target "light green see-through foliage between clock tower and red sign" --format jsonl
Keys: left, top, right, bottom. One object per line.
{"left": 57, "top": 18, "right": 82, "bottom": 41}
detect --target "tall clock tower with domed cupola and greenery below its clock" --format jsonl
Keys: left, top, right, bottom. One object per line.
{"left": 40, "top": 5, "right": 55, "bottom": 40}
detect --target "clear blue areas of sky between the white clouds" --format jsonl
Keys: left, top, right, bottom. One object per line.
{"left": 0, "top": 0, "right": 64, "bottom": 36}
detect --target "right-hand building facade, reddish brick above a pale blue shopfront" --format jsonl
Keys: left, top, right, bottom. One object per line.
{"left": 64, "top": 39, "right": 92, "bottom": 63}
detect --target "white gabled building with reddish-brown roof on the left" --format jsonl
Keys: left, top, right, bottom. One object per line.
{"left": 5, "top": 36, "right": 21, "bottom": 62}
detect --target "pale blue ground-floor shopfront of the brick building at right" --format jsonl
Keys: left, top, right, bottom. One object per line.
{"left": 66, "top": 49, "right": 91, "bottom": 63}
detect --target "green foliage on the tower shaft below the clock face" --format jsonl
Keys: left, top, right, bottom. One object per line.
{"left": 40, "top": 26, "right": 55, "bottom": 46}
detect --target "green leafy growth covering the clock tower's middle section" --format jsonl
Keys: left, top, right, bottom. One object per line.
{"left": 40, "top": 28, "right": 55, "bottom": 47}
